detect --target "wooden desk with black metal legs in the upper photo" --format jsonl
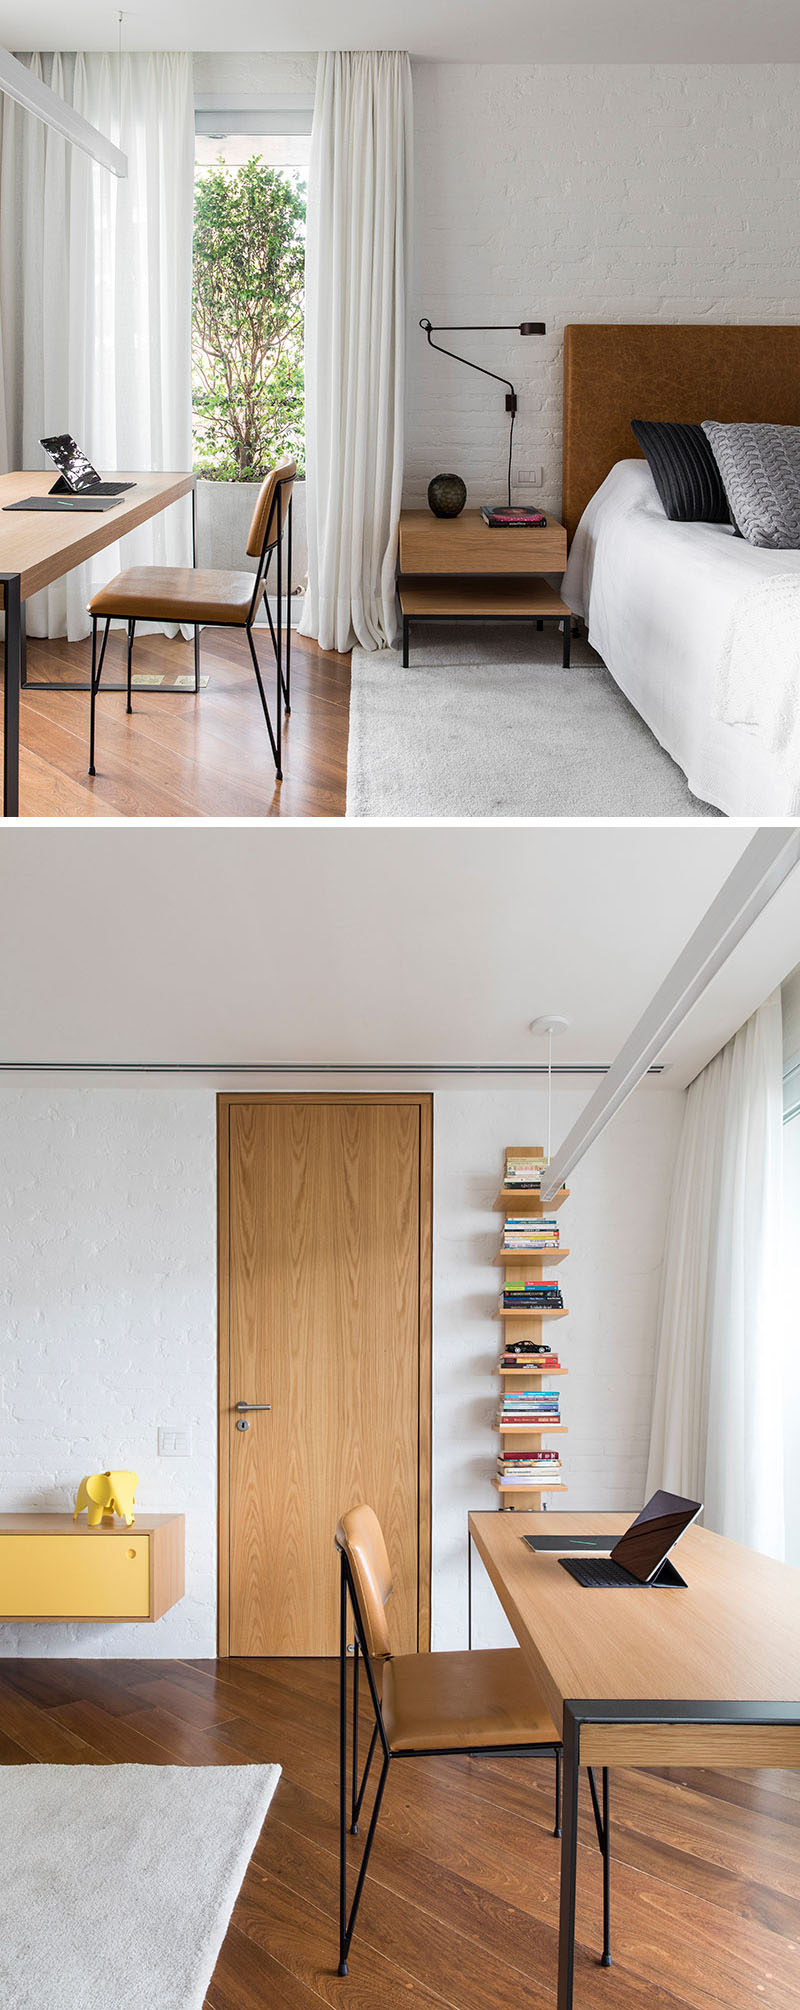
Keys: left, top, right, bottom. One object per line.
{"left": 0, "top": 470, "right": 197, "bottom": 816}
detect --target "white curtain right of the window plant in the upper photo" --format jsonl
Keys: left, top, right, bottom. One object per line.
{"left": 299, "top": 52, "right": 412, "bottom": 649}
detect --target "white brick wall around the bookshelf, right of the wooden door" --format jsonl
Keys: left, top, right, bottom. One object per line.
{"left": 434, "top": 1089, "right": 683, "bottom": 1648}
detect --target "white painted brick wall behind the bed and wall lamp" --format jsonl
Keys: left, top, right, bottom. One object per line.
{"left": 406, "top": 62, "right": 800, "bottom": 509}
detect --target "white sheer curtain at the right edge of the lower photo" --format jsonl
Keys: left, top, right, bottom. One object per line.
{"left": 647, "top": 991, "right": 784, "bottom": 1558}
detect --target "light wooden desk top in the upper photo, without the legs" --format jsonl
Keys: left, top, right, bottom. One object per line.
{"left": 0, "top": 468, "right": 195, "bottom": 601}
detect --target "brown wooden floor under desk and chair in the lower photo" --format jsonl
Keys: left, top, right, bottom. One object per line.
{"left": 0, "top": 1660, "right": 800, "bottom": 2010}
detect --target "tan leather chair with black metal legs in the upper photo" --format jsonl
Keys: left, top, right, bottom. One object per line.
{"left": 88, "top": 460, "right": 297, "bottom": 782}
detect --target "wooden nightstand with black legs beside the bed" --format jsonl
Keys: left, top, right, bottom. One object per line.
{"left": 398, "top": 509, "right": 571, "bottom": 669}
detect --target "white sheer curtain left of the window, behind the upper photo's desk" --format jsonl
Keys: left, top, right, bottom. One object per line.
{"left": 0, "top": 54, "right": 195, "bottom": 639}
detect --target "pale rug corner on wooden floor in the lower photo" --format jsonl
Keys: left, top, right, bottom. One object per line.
{"left": 0, "top": 1765, "right": 281, "bottom": 2010}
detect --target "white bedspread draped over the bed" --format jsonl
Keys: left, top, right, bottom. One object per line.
{"left": 563, "top": 460, "right": 800, "bottom": 816}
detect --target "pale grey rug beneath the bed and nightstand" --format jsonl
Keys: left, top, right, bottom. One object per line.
{"left": 348, "top": 621, "right": 720, "bottom": 818}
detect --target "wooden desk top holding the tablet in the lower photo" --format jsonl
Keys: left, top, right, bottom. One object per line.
{"left": 470, "top": 1514, "right": 800, "bottom": 1725}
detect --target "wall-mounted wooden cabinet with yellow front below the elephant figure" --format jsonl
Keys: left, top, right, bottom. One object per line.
{"left": 0, "top": 1514, "right": 185, "bottom": 1622}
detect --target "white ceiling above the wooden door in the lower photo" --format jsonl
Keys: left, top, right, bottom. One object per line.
{"left": 0, "top": 824, "right": 800, "bottom": 1087}
